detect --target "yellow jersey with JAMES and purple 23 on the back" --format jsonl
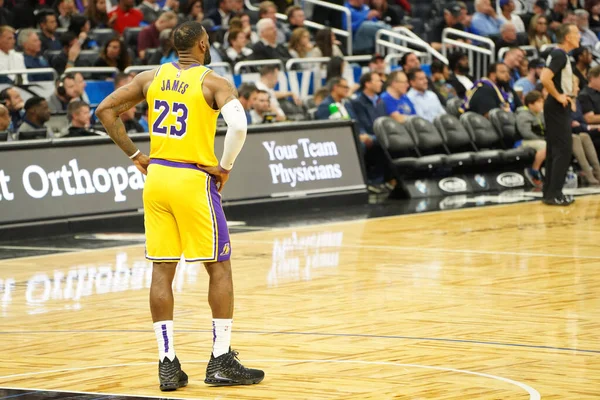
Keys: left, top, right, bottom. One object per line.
{"left": 146, "top": 63, "right": 219, "bottom": 166}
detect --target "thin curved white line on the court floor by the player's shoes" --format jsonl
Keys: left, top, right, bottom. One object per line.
{"left": 0, "top": 359, "right": 542, "bottom": 400}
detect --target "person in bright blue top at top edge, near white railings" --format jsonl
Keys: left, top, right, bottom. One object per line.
{"left": 342, "top": 0, "right": 391, "bottom": 54}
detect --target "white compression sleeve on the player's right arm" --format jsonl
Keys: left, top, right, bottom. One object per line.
{"left": 221, "top": 99, "right": 248, "bottom": 170}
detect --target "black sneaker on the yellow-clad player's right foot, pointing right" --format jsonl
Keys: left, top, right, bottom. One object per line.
{"left": 204, "top": 349, "right": 265, "bottom": 386}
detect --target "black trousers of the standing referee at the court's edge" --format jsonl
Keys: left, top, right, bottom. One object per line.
{"left": 544, "top": 96, "right": 573, "bottom": 199}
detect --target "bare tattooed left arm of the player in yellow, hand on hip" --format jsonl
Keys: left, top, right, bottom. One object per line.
{"left": 96, "top": 70, "right": 155, "bottom": 173}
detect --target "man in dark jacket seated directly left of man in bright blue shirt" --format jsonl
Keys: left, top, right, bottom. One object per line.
{"left": 351, "top": 72, "right": 387, "bottom": 139}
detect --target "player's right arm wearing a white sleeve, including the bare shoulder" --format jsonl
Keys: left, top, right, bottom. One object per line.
{"left": 204, "top": 74, "right": 248, "bottom": 172}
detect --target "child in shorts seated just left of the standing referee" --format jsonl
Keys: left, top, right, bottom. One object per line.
{"left": 516, "top": 90, "right": 546, "bottom": 188}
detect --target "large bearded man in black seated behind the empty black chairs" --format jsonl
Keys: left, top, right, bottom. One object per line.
{"left": 463, "top": 63, "right": 522, "bottom": 118}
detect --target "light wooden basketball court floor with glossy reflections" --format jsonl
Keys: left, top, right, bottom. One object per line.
{"left": 0, "top": 196, "right": 600, "bottom": 400}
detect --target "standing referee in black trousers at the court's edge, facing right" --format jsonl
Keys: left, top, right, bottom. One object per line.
{"left": 540, "top": 24, "right": 581, "bottom": 206}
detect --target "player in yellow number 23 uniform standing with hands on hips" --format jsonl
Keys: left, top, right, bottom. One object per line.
{"left": 96, "top": 21, "right": 264, "bottom": 391}
